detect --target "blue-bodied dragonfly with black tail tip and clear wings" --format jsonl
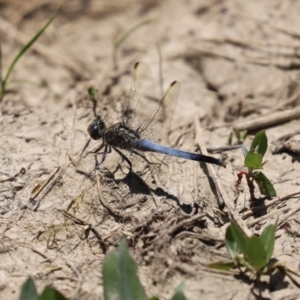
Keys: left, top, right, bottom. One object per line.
{"left": 87, "top": 62, "right": 226, "bottom": 172}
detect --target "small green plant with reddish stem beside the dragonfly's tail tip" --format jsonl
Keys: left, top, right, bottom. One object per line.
{"left": 236, "top": 131, "right": 276, "bottom": 200}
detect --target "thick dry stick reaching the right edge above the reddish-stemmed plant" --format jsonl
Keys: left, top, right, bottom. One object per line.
{"left": 234, "top": 107, "right": 300, "bottom": 131}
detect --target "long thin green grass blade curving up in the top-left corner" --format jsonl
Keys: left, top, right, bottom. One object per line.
{"left": 0, "top": 0, "right": 66, "bottom": 102}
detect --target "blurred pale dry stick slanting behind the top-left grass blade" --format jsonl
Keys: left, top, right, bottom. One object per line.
{"left": 0, "top": 16, "right": 91, "bottom": 78}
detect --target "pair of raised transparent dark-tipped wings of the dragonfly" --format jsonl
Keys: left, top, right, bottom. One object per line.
{"left": 123, "top": 62, "right": 180, "bottom": 141}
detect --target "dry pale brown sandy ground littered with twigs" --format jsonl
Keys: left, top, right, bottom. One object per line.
{"left": 0, "top": 0, "right": 300, "bottom": 300}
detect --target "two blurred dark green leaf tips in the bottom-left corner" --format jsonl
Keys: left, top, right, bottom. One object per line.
{"left": 19, "top": 277, "right": 67, "bottom": 300}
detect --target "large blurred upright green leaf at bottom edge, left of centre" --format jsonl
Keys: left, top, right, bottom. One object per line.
{"left": 103, "top": 239, "right": 148, "bottom": 300}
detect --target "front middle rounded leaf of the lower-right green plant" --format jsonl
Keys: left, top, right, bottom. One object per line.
{"left": 245, "top": 235, "right": 269, "bottom": 270}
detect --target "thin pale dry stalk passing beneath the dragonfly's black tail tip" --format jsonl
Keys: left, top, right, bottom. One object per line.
{"left": 194, "top": 115, "right": 252, "bottom": 236}
